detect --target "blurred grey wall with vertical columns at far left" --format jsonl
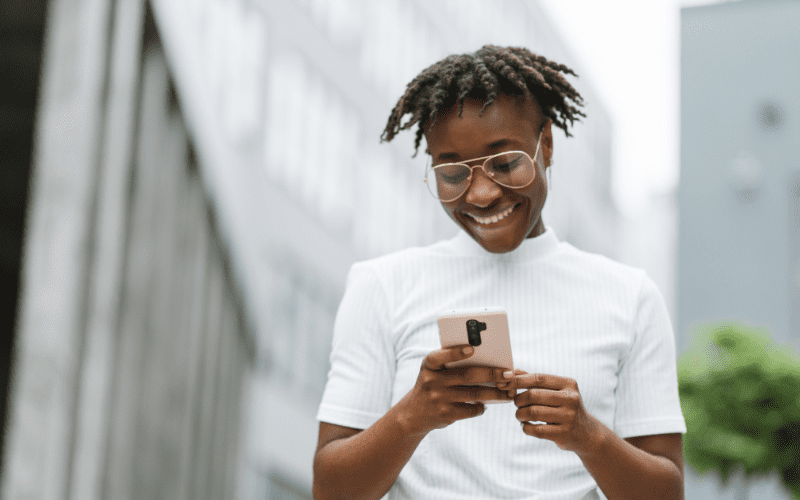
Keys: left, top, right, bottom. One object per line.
{"left": 0, "top": 0, "right": 255, "bottom": 500}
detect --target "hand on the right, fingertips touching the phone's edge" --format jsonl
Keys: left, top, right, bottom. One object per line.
{"left": 508, "top": 370, "right": 603, "bottom": 453}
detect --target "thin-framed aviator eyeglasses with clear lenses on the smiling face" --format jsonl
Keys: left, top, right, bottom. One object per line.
{"left": 424, "top": 132, "right": 541, "bottom": 202}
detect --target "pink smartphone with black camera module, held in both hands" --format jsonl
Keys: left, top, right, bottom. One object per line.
{"left": 438, "top": 307, "right": 514, "bottom": 403}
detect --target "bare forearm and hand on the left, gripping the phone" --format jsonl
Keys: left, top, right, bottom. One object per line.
{"left": 314, "top": 345, "right": 514, "bottom": 500}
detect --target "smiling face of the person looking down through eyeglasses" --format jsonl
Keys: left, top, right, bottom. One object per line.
{"left": 425, "top": 94, "right": 553, "bottom": 253}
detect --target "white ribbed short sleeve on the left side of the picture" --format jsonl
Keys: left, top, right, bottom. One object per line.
{"left": 317, "top": 262, "right": 396, "bottom": 429}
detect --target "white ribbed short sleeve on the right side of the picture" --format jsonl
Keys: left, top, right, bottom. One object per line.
{"left": 614, "top": 273, "right": 686, "bottom": 438}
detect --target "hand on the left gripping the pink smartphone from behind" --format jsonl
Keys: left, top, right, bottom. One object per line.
{"left": 402, "top": 344, "right": 516, "bottom": 434}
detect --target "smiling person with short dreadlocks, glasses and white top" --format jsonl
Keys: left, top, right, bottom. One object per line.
{"left": 314, "top": 46, "right": 686, "bottom": 500}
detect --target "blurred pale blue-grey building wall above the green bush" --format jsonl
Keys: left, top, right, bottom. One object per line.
{"left": 677, "top": 0, "right": 800, "bottom": 500}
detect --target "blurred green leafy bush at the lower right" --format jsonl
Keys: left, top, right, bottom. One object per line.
{"left": 678, "top": 322, "right": 800, "bottom": 499}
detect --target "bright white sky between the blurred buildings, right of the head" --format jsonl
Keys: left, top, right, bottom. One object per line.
{"left": 539, "top": 0, "right": 736, "bottom": 217}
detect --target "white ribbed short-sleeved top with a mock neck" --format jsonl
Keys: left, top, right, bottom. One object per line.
{"left": 317, "top": 227, "right": 686, "bottom": 500}
